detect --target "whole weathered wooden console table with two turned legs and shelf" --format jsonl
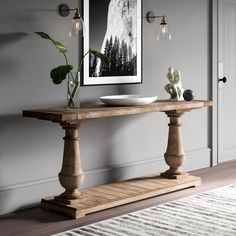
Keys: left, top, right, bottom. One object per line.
{"left": 23, "top": 100, "right": 212, "bottom": 218}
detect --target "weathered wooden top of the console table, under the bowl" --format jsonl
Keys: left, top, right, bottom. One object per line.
{"left": 23, "top": 100, "right": 213, "bottom": 123}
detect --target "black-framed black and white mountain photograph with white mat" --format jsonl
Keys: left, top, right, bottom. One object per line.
{"left": 83, "top": 0, "right": 142, "bottom": 85}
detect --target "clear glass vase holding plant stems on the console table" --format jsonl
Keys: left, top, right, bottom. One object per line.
{"left": 67, "top": 72, "right": 80, "bottom": 109}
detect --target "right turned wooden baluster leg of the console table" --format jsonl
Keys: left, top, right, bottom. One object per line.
{"left": 161, "top": 111, "right": 187, "bottom": 179}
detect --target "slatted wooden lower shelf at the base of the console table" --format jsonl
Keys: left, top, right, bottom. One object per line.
{"left": 41, "top": 175, "right": 201, "bottom": 219}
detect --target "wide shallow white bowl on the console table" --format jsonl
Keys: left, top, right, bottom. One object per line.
{"left": 100, "top": 94, "right": 157, "bottom": 106}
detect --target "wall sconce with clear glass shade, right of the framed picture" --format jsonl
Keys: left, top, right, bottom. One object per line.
{"left": 146, "top": 11, "right": 171, "bottom": 40}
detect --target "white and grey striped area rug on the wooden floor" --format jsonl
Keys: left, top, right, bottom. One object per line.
{"left": 56, "top": 185, "right": 236, "bottom": 236}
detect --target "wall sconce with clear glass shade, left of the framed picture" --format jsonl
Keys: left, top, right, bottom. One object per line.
{"left": 57, "top": 4, "right": 85, "bottom": 37}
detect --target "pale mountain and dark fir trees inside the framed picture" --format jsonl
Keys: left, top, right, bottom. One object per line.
{"left": 90, "top": 0, "right": 137, "bottom": 77}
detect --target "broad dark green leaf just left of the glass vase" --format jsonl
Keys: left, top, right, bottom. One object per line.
{"left": 50, "top": 65, "right": 73, "bottom": 84}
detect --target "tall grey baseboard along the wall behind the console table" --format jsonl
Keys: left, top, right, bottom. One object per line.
{"left": 0, "top": 148, "right": 211, "bottom": 215}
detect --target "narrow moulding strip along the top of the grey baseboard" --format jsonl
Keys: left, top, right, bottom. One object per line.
{"left": 0, "top": 148, "right": 211, "bottom": 193}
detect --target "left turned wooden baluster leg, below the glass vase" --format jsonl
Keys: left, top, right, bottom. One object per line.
{"left": 59, "top": 124, "right": 84, "bottom": 200}
